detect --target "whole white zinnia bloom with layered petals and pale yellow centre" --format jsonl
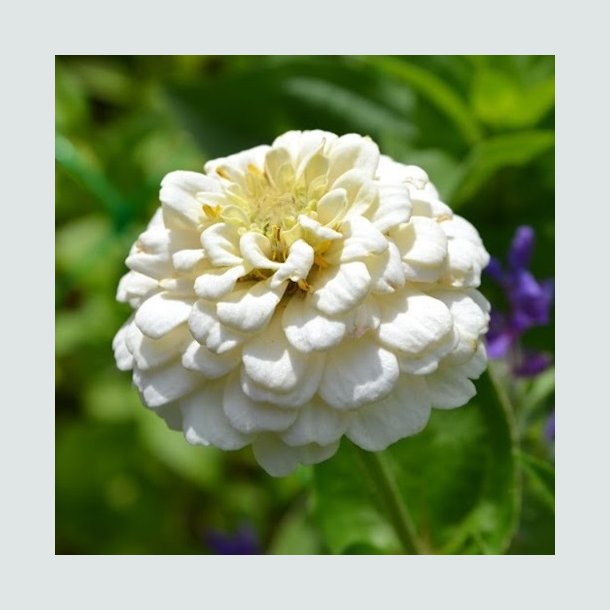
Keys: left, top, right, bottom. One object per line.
{"left": 114, "top": 131, "right": 489, "bottom": 476}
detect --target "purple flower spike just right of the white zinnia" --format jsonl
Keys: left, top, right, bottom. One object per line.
{"left": 486, "top": 226, "right": 554, "bottom": 377}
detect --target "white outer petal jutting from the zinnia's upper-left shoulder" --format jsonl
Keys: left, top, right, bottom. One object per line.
{"left": 159, "top": 171, "right": 220, "bottom": 227}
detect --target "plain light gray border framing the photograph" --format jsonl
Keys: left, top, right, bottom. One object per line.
{"left": 0, "top": 0, "right": 610, "bottom": 610}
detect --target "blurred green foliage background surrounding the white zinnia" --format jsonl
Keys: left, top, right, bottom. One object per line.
{"left": 55, "top": 56, "right": 554, "bottom": 554}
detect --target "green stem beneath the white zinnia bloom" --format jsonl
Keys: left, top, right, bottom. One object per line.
{"left": 354, "top": 445, "right": 421, "bottom": 555}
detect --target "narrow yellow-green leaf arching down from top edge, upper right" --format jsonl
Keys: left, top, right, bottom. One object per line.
{"left": 363, "top": 56, "right": 482, "bottom": 144}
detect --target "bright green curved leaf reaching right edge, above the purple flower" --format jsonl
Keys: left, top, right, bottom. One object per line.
{"left": 450, "top": 131, "right": 555, "bottom": 203}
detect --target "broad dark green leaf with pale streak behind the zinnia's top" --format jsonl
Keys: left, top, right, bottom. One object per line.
{"left": 166, "top": 57, "right": 415, "bottom": 156}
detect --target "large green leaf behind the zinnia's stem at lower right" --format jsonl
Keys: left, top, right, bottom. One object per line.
{"left": 315, "top": 374, "right": 520, "bottom": 553}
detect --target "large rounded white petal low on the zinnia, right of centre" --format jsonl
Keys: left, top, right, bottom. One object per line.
{"left": 319, "top": 337, "right": 399, "bottom": 409}
